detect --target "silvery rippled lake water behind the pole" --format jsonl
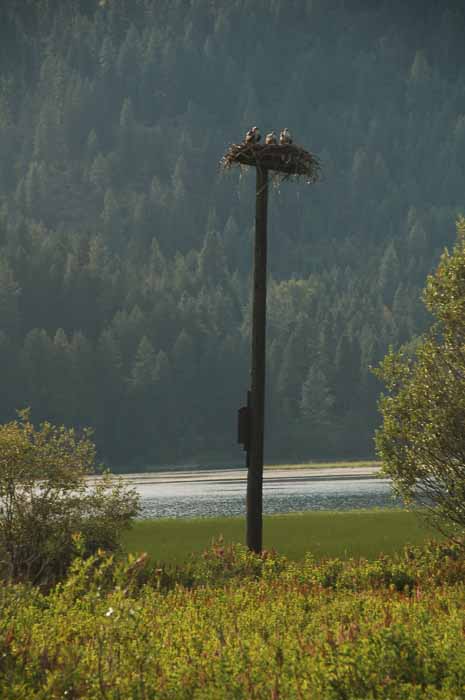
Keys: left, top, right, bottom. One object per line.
{"left": 121, "top": 470, "right": 402, "bottom": 518}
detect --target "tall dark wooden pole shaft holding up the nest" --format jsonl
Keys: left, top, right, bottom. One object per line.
{"left": 247, "top": 165, "right": 268, "bottom": 552}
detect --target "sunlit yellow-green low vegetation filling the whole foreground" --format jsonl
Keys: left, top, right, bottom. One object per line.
{"left": 0, "top": 543, "right": 465, "bottom": 700}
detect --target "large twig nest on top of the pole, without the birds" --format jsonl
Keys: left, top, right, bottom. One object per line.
{"left": 221, "top": 143, "right": 321, "bottom": 184}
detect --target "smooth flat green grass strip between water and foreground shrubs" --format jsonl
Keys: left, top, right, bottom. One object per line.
{"left": 124, "top": 510, "right": 437, "bottom": 562}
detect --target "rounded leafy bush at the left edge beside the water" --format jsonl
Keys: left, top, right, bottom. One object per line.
{"left": 0, "top": 411, "right": 138, "bottom": 586}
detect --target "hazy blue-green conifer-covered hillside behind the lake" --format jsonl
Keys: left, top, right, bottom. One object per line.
{"left": 0, "top": 0, "right": 465, "bottom": 468}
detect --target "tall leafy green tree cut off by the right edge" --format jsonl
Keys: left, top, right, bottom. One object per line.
{"left": 376, "top": 217, "right": 465, "bottom": 536}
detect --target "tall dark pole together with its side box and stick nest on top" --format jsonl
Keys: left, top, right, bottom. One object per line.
{"left": 222, "top": 137, "right": 320, "bottom": 553}
